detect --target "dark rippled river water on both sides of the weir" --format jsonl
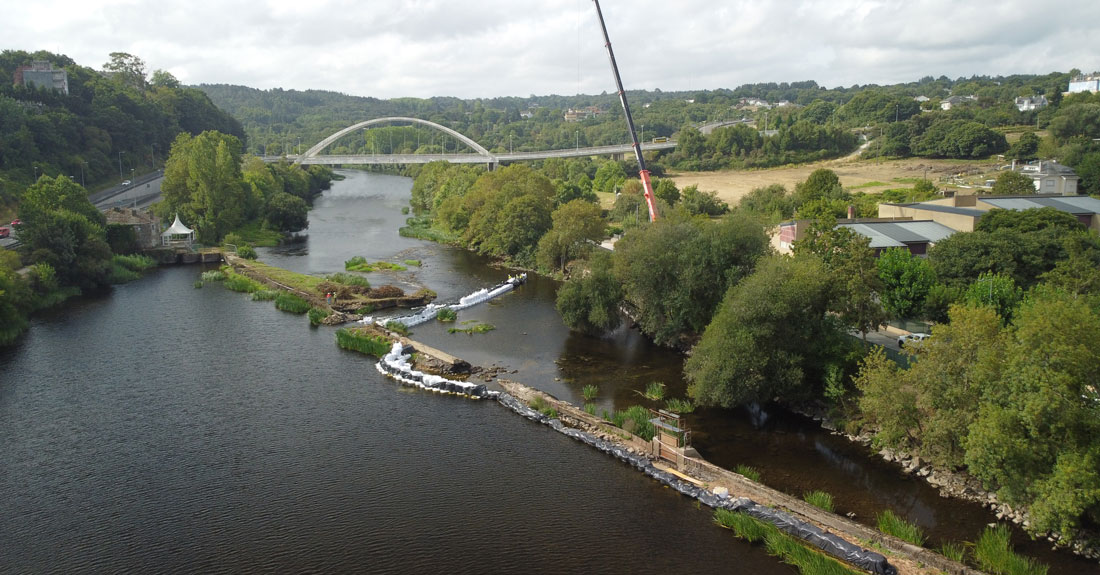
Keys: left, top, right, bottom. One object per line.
{"left": 0, "top": 172, "right": 1100, "bottom": 574}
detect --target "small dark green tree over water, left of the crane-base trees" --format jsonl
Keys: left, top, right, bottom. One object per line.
{"left": 557, "top": 252, "right": 623, "bottom": 334}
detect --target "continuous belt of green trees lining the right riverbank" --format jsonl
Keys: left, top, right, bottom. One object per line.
{"left": 411, "top": 152, "right": 1100, "bottom": 567}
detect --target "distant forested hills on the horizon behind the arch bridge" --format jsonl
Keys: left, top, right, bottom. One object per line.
{"left": 198, "top": 70, "right": 1079, "bottom": 169}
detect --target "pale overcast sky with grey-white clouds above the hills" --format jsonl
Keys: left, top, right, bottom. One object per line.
{"left": 8, "top": 0, "right": 1100, "bottom": 98}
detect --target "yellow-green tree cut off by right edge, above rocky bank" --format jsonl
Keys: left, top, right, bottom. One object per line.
{"left": 966, "top": 290, "right": 1100, "bottom": 537}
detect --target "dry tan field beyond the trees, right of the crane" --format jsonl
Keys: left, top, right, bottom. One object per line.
{"left": 668, "top": 157, "right": 999, "bottom": 206}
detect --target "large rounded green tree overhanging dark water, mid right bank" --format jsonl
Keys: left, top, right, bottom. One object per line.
{"left": 684, "top": 255, "right": 845, "bottom": 407}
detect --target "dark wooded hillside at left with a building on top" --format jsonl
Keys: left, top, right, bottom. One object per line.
{"left": 0, "top": 49, "right": 244, "bottom": 213}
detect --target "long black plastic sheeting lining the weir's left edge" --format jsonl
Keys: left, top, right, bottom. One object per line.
{"left": 496, "top": 394, "right": 898, "bottom": 575}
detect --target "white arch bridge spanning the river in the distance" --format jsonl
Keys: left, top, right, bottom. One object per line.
{"left": 279, "top": 117, "right": 677, "bottom": 168}
